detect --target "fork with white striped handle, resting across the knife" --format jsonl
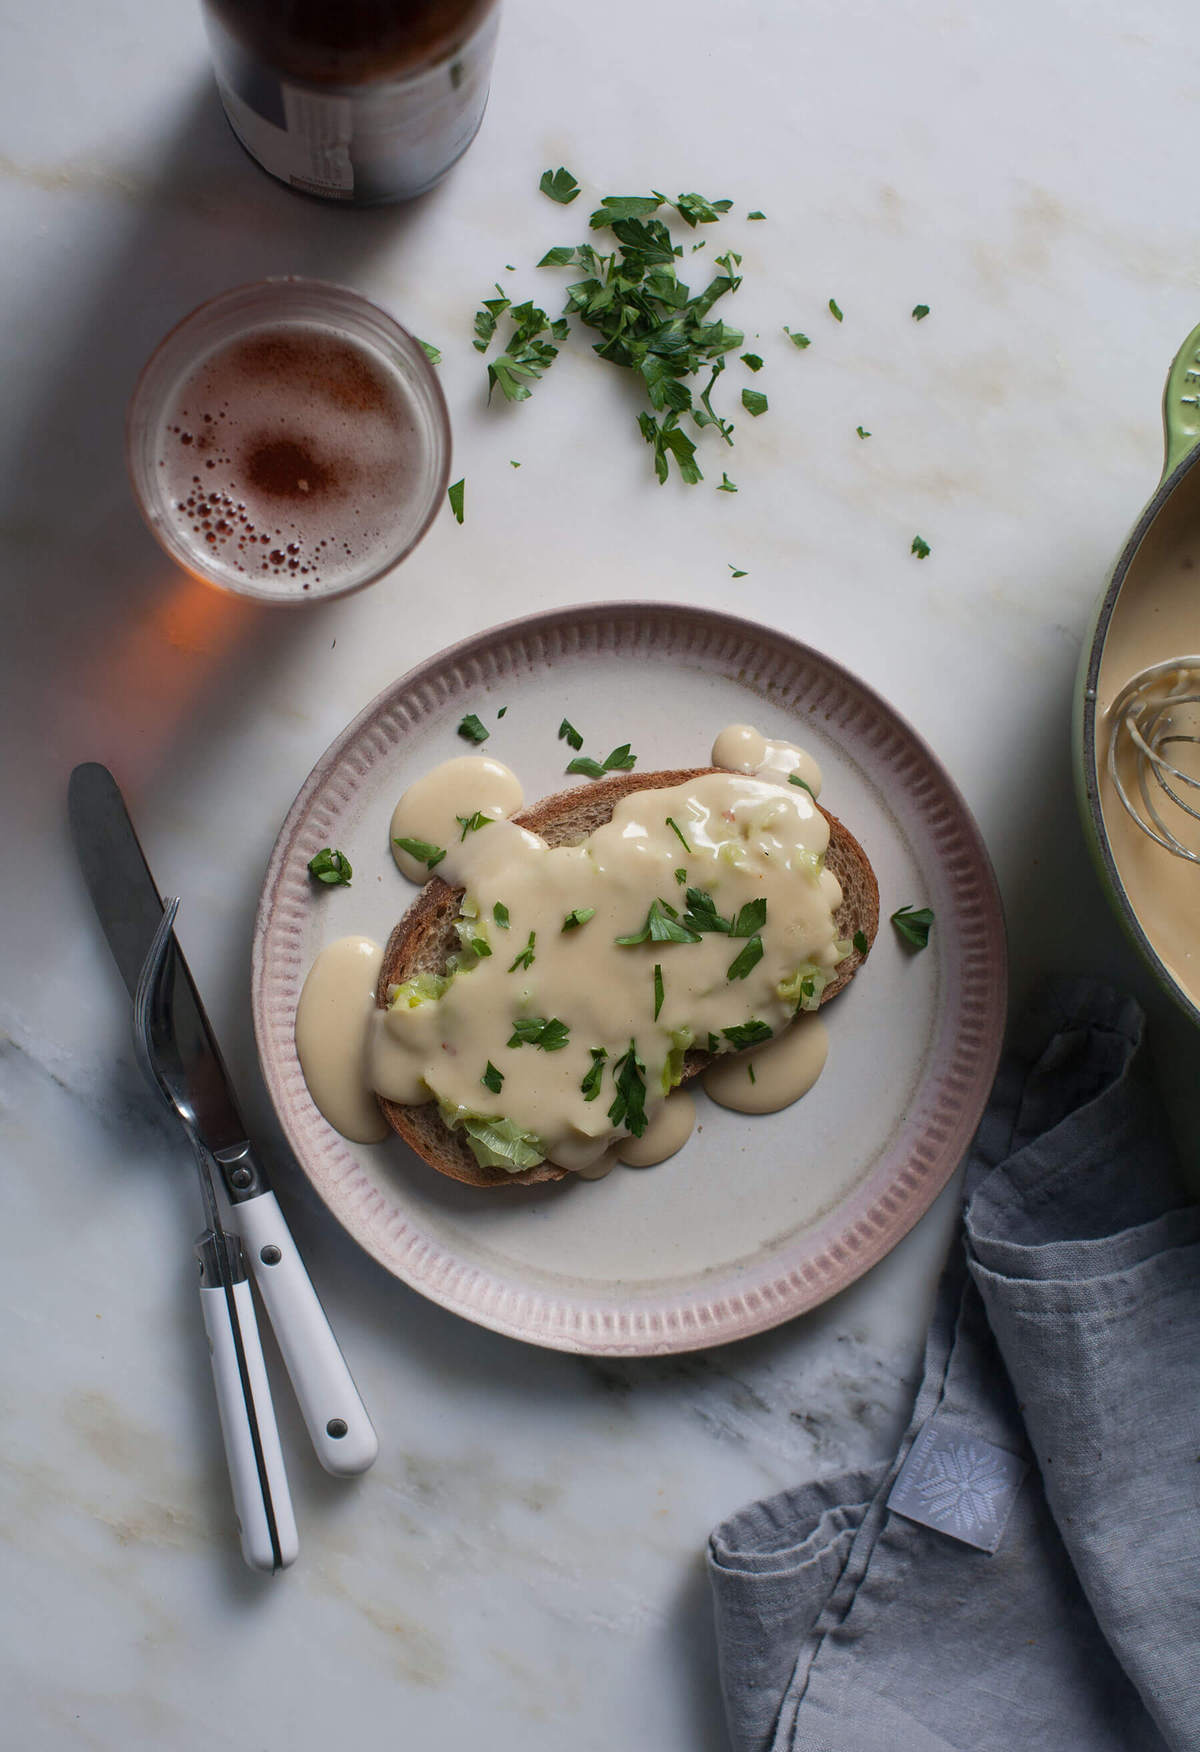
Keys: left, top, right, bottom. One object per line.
{"left": 133, "top": 899, "right": 300, "bottom": 1572}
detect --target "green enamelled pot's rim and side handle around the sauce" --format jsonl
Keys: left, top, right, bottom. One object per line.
{"left": 1072, "top": 328, "right": 1200, "bottom": 1025}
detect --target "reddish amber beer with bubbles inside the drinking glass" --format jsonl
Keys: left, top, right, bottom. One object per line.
{"left": 156, "top": 322, "right": 420, "bottom": 597}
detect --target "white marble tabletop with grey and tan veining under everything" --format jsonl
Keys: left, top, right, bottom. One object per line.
{"left": 0, "top": 0, "right": 1200, "bottom": 1752}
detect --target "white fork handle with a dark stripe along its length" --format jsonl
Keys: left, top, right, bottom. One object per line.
{"left": 200, "top": 1279, "right": 300, "bottom": 1572}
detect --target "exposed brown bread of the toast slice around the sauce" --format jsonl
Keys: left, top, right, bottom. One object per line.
{"left": 375, "top": 767, "right": 879, "bottom": 1186}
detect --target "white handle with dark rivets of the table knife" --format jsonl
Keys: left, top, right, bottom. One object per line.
{"left": 231, "top": 1193, "right": 378, "bottom": 1477}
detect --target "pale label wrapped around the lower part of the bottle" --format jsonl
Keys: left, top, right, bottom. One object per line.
{"left": 210, "top": 9, "right": 499, "bottom": 203}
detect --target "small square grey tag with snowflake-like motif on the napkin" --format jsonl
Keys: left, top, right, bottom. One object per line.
{"left": 888, "top": 1417, "right": 1028, "bottom": 1551}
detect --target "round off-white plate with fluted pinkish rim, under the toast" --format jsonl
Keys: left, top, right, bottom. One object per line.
{"left": 254, "top": 603, "right": 1006, "bottom": 1354}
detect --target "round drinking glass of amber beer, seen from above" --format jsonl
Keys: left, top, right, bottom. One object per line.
{"left": 126, "top": 279, "right": 450, "bottom": 603}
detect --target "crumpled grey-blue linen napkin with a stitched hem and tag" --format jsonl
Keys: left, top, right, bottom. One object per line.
{"left": 709, "top": 981, "right": 1200, "bottom": 1752}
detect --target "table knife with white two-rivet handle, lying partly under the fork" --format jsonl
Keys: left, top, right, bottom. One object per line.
{"left": 68, "top": 760, "right": 378, "bottom": 1477}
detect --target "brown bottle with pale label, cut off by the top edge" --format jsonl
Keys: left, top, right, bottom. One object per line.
{"left": 203, "top": 0, "right": 499, "bottom": 207}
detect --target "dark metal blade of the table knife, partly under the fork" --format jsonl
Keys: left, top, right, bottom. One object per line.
{"left": 67, "top": 760, "right": 245, "bottom": 1153}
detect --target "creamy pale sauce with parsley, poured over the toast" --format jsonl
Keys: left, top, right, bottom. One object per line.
{"left": 296, "top": 725, "right": 848, "bottom": 1179}
